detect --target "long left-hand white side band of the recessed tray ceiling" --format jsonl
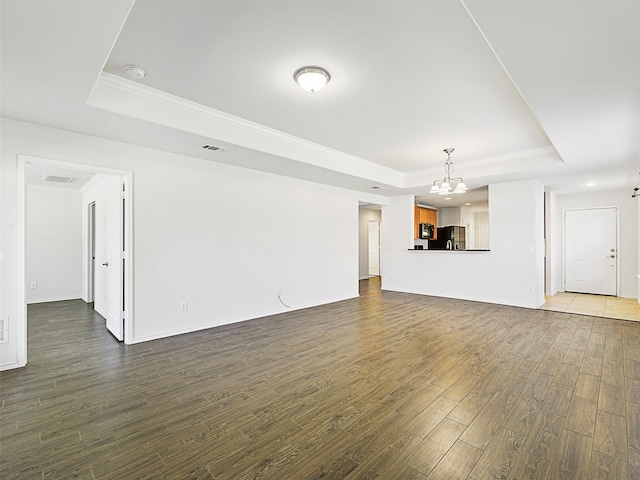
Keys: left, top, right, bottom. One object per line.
{"left": 87, "top": 72, "right": 405, "bottom": 188}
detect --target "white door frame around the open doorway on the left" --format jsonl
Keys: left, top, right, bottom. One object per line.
{"left": 15, "top": 154, "right": 134, "bottom": 367}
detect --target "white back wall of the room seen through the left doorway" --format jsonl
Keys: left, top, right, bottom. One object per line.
{"left": 25, "top": 186, "right": 82, "bottom": 303}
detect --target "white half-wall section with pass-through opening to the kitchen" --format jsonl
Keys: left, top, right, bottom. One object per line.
{"left": 382, "top": 181, "right": 544, "bottom": 308}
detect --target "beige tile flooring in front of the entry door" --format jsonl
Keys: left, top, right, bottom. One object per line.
{"left": 540, "top": 292, "right": 640, "bottom": 321}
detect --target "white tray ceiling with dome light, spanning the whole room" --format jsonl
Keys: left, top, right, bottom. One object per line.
{"left": 0, "top": 0, "right": 640, "bottom": 206}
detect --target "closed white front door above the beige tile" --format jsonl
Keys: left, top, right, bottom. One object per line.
{"left": 564, "top": 208, "right": 618, "bottom": 295}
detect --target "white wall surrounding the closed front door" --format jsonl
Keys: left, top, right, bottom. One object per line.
{"left": 552, "top": 189, "right": 638, "bottom": 298}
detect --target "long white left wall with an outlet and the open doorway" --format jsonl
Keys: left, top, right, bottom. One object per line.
{"left": 0, "top": 119, "right": 386, "bottom": 368}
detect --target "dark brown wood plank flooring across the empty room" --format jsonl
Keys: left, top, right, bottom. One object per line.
{"left": 0, "top": 279, "right": 640, "bottom": 480}
